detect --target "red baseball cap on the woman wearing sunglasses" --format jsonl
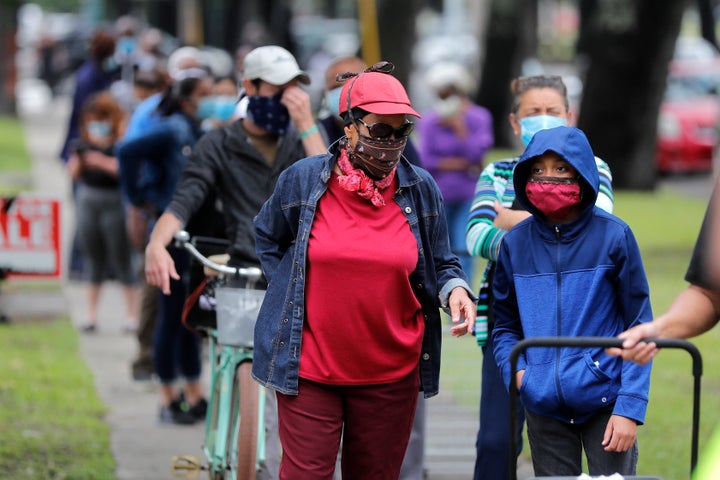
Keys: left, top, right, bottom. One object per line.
{"left": 339, "top": 72, "right": 420, "bottom": 118}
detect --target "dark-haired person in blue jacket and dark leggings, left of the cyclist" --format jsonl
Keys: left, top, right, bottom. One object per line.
{"left": 117, "top": 69, "right": 213, "bottom": 424}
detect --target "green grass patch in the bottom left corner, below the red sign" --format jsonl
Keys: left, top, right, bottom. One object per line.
{"left": 0, "top": 318, "right": 115, "bottom": 480}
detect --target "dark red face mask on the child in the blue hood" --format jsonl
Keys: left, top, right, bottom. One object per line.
{"left": 525, "top": 177, "right": 582, "bottom": 220}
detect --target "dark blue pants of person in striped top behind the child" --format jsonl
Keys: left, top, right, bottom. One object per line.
{"left": 473, "top": 335, "right": 525, "bottom": 480}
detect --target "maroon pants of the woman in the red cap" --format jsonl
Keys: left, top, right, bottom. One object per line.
{"left": 277, "top": 370, "right": 420, "bottom": 480}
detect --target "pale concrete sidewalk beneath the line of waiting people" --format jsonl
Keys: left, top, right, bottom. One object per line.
{"left": 14, "top": 95, "right": 532, "bottom": 480}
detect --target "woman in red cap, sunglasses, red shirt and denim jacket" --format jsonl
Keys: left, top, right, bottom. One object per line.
{"left": 253, "top": 62, "right": 476, "bottom": 480}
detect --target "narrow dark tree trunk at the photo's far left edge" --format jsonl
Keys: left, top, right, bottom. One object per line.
{"left": 0, "top": 1, "right": 18, "bottom": 115}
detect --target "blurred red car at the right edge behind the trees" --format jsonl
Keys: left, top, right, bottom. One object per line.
{"left": 655, "top": 61, "right": 720, "bottom": 174}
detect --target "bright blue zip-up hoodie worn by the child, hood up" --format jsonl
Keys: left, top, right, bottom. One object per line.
{"left": 493, "top": 127, "right": 652, "bottom": 424}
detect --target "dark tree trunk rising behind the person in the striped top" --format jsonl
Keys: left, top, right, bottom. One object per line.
{"left": 476, "top": 0, "right": 536, "bottom": 148}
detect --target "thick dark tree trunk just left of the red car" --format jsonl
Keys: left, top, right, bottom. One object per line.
{"left": 578, "top": 0, "right": 687, "bottom": 190}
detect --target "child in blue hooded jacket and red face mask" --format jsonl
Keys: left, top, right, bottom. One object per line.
{"left": 493, "top": 126, "right": 652, "bottom": 476}
